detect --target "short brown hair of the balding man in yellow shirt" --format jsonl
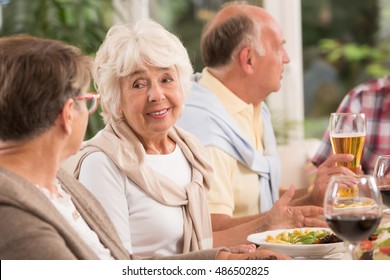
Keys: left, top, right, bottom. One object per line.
{"left": 200, "top": 12, "right": 261, "bottom": 67}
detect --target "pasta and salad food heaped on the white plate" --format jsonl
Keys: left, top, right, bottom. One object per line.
{"left": 266, "top": 228, "right": 342, "bottom": 245}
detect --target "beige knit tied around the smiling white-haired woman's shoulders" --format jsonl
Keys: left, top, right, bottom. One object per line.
{"left": 74, "top": 120, "right": 212, "bottom": 253}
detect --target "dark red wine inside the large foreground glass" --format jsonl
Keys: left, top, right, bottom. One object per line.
{"left": 326, "top": 215, "right": 381, "bottom": 243}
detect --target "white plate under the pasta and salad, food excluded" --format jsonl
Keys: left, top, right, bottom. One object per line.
{"left": 247, "top": 228, "right": 346, "bottom": 257}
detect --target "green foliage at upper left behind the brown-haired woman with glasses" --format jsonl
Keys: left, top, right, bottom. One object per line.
{"left": 0, "top": 0, "right": 114, "bottom": 139}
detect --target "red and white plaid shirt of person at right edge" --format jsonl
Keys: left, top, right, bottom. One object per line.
{"left": 312, "top": 76, "right": 390, "bottom": 174}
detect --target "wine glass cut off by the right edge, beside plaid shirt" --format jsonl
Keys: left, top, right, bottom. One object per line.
{"left": 373, "top": 155, "right": 390, "bottom": 213}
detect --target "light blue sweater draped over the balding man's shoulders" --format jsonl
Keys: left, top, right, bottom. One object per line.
{"left": 177, "top": 77, "right": 280, "bottom": 212}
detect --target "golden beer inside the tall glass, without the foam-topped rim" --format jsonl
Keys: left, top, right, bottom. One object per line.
{"left": 330, "top": 133, "right": 366, "bottom": 173}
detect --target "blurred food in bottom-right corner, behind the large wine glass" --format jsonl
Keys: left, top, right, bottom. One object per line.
{"left": 355, "top": 223, "right": 390, "bottom": 260}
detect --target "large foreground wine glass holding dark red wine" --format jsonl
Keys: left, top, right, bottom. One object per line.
{"left": 324, "top": 175, "right": 382, "bottom": 258}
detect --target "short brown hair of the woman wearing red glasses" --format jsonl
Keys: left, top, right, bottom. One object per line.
{"left": 0, "top": 35, "right": 92, "bottom": 141}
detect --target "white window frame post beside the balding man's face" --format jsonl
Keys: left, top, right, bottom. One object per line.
{"left": 264, "top": 0, "right": 310, "bottom": 188}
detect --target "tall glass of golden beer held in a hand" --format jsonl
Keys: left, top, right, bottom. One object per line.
{"left": 329, "top": 113, "right": 366, "bottom": 174}
